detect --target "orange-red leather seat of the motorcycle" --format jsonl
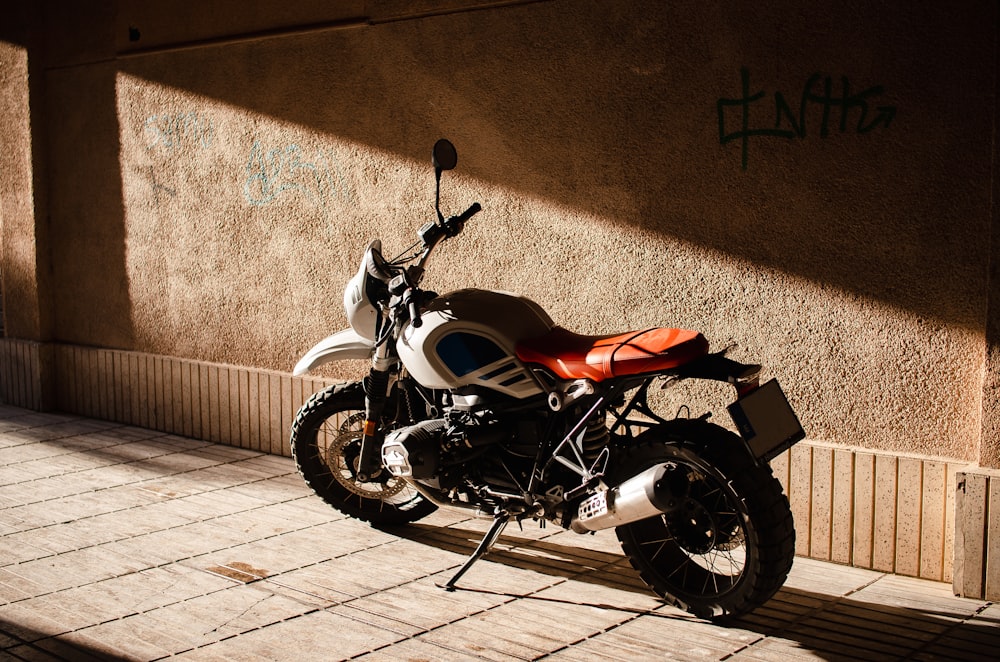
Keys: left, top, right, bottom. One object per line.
{"left": 517, "top": 326, "right": 708, "bottom": 382}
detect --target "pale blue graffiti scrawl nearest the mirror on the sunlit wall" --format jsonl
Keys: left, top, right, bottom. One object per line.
{"left": 243, "top": 140, "right": 349, "bottom": 207}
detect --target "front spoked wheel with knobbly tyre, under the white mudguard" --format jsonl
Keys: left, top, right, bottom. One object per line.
{"left": 291, "top": 383, "right": 437, "bottom": 524}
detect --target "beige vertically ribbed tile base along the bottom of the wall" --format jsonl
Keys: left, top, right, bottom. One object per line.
{"left": 0, "top": 340, "right": 984, "bottom": 597}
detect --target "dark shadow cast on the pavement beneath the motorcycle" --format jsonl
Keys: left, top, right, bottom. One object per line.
{"left": 384, "top": 524, "right": 1000, "bottom": 660}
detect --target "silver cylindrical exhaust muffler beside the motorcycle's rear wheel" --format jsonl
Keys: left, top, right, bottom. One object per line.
{"left": 569, "top": 463, "right": 688, "bottom": 533}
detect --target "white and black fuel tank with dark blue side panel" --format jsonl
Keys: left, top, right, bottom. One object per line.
{"left": 396, "top": 289, "right": 554, "bottom": 399}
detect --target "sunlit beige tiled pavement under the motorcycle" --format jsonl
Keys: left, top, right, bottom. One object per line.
{"left": 0, "top": 406, "right": 1000, "bottom": 662}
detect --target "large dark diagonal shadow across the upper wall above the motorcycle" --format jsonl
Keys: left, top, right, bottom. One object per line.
{"left": 119, "top": 2, "right": 996, "bottom": 330}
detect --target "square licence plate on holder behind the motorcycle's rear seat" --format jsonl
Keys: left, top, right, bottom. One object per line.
{"left": 728, "top": 379, "right": 806, "bottom": 462}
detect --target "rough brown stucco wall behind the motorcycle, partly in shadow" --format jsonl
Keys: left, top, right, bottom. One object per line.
{"left": 0, "top": 0, "right": 1000, "bottom": 596}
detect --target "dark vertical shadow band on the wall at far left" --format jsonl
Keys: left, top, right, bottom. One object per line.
{"left": 0, "top": 2, "right": 134, "bottom": 347}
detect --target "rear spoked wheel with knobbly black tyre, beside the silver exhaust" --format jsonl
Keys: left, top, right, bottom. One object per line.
{"left": 616, "top": 421, "right": 795, "bottom": 618}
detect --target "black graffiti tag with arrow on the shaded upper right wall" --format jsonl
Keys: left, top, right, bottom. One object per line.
{"left": 717, "top": 67, "right": 896, "bottom": 170}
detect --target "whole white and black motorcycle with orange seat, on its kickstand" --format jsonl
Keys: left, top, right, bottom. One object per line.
{"left": 291, "top": 139, "right": 805, "bottom": 619}
